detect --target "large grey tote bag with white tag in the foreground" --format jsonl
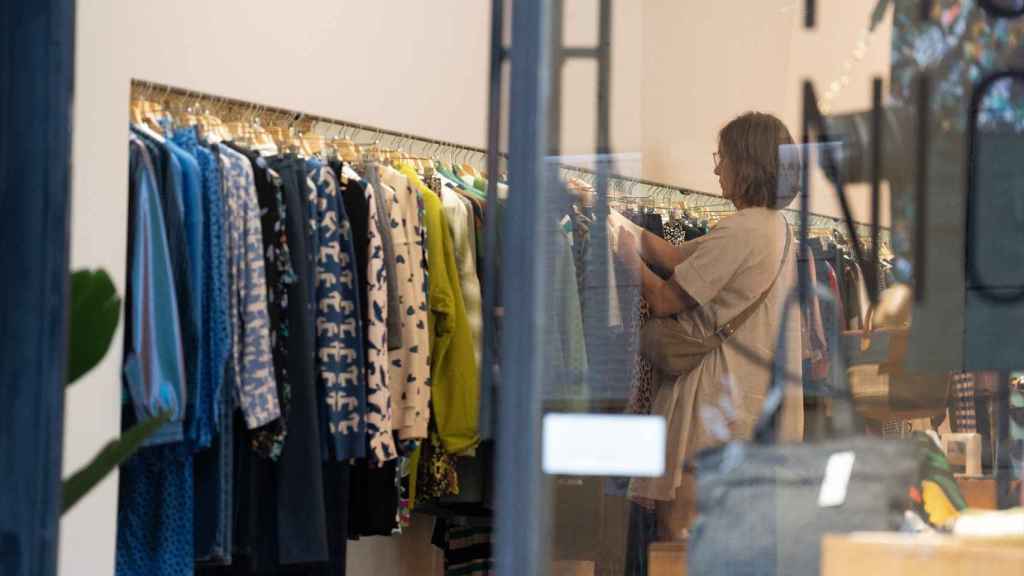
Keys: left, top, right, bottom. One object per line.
{"left": 688, "top": 295, "right": 923, "bottom": 576}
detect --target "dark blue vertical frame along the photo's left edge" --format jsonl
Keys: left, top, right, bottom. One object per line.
{"left": 0, "top": 0, "right": 75, "bottom": 576}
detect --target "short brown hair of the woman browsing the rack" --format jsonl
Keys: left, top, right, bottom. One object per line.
{"left": 718, "top": 112, "right": 800, "bottom": 209}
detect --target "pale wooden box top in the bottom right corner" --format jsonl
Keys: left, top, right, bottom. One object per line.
{"left": 821, "top": 532, "right": 1024, "bottom": 576}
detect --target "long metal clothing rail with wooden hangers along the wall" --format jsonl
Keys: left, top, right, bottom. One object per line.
{"left": 131, "top": 79, "right": 889, "bottom": 244}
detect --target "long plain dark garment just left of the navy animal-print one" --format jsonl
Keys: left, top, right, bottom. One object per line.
{"left": 267, "top": 157, "right": 328, "bottom": 565}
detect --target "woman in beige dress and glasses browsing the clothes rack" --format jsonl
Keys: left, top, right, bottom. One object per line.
{"left": 616, "top": 112, "right": 803, "bottom": 540}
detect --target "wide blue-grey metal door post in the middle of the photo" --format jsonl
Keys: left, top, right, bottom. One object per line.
{"left": 488, "top": 0, "right": 551, "bottom": 575}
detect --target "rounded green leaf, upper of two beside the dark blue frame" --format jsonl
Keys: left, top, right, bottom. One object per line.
{"left": 66, "top": 270, "right": 121, "bottom": 385}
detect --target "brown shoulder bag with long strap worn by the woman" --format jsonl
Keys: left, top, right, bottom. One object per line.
{"left": 640, "top": 222, "right": 792, "bottom": 377}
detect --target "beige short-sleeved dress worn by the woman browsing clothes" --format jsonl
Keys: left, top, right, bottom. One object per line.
{"left": 630, "top": 208, "right": 804, "bottom": 500}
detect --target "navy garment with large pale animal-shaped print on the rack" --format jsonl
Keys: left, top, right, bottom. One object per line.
{"left": 307, "top": 159, "right": 367, "bottom": 460}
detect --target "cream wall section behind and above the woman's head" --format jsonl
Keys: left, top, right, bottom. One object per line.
{"left": 642, "top": 0, "right": 892, "bottom": 221}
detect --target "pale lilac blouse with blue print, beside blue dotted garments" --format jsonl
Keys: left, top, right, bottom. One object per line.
{"left": 217, "top": 145, "right": 281, "bottom": 429}
